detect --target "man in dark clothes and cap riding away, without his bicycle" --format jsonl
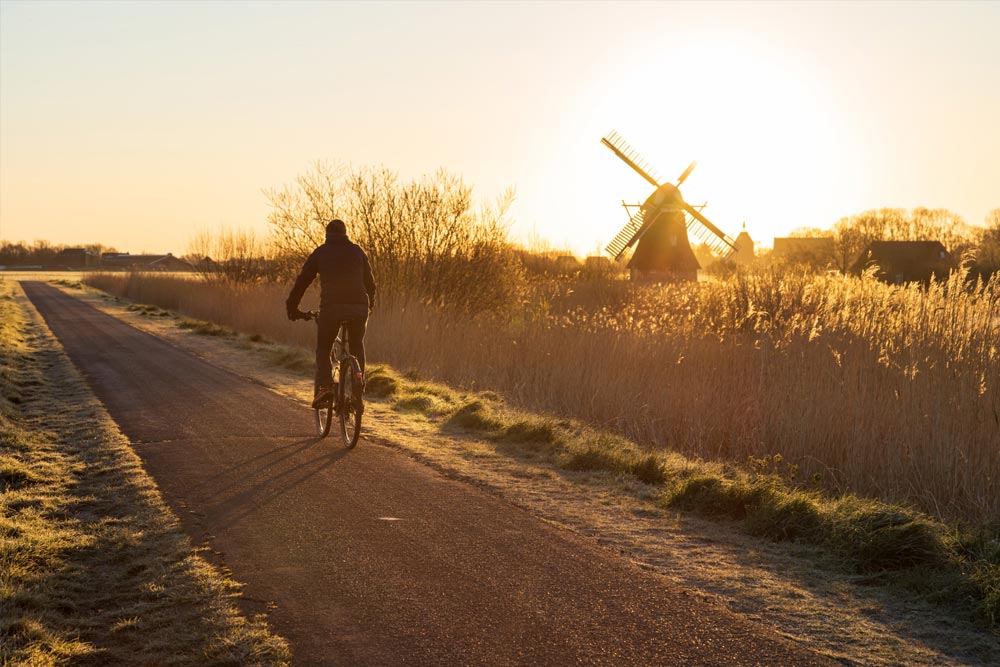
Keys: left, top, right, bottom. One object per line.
{"left": 285, "top": 220, "right": 375, "bottom": 407}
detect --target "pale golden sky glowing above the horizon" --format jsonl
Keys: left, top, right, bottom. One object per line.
{"left": 0, "top": 0, "right": 1000, "bottom": 255}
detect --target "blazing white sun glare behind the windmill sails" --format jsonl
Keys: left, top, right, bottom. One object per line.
{"left": 580, "top": 34, "right": 846, "bottom": 245}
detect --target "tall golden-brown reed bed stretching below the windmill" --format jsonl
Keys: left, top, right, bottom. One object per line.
{"left": 86, "top": 273, "right": 1000, "bottom": 525}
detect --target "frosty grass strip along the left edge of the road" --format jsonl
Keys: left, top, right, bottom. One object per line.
{"left": 0, "top": 280, "right": 289, "bottom": 667}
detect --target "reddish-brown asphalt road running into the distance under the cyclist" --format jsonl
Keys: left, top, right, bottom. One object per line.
{"left": 22, "top": 282, "right": 836, "bottom": 667}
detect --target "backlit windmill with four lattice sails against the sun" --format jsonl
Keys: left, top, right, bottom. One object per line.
{"left": 601, "top": 132, "right": 736, "bottom": 280}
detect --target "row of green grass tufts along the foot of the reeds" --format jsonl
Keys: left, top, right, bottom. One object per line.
{"left": 369, "top": 366, "right": 1000, "bottom": 631}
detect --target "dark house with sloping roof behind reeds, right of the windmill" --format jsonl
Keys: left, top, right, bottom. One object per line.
{"left": 851, "top": 241, "right": 955, "bottom": 285}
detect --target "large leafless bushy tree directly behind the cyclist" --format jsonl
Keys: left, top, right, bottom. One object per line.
{"left": 265, "top": 163, "right": 521, "bottom": 310}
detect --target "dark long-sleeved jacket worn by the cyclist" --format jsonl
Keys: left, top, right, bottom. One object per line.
{"left": 285, "top": 234, "right": 375, "bottom": 311}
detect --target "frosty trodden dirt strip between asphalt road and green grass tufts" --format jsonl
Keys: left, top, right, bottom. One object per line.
{"left": 60, "top": 282, "right": 1000, "bottom": 665}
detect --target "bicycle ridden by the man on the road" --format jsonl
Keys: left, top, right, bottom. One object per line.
{"left": 303, "top": 311, "right": 364, "bottom": 449}
